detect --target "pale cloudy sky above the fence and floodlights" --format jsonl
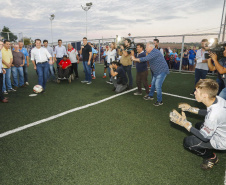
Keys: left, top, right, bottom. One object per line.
{"left": 0, "top": 0, "right": 224, "bottom": 41}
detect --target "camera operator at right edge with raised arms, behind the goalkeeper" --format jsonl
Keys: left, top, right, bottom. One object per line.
{"left": 208, "top": 47, "right": 226, "bottom": 100}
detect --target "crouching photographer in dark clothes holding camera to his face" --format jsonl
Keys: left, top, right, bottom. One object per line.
{"left": 109, "top": 61, "right": 128, "bottom": 93}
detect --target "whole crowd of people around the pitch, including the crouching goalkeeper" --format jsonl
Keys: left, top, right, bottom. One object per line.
{"left": 0, "top": 37, "right": 226, "bottom": 170}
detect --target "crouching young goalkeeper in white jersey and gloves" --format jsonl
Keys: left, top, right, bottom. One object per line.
{"left": 169, "top": 79, "right": 226, "bottom": 170}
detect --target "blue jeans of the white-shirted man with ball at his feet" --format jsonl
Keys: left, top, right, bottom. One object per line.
{"left": 36, "top": 62, "right": 49, "bottom": 90}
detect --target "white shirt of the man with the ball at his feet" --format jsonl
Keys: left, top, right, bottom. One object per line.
{"left": 31, "top": 47, "right": 52, "bottom": 64}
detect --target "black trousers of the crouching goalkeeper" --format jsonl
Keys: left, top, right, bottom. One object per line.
{"left": 184, "top": 123, "right": 214, "bottom": 159}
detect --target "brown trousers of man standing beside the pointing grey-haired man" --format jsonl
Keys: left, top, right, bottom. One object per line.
{"left": 136, "top": 71, "right": 149, "bottom": 94}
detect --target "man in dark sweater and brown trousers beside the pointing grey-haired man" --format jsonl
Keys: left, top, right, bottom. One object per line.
{"left": 134, "top": 43, "right": 149, "bottom": 95}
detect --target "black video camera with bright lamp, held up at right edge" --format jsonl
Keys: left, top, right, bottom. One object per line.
{"left": 205, "top": 38, "right": 226, "bottom": 59}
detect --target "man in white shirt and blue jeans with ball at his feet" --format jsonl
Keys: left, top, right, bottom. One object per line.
{"left": 31, "top": 39, "right": 53, "bottom": 92}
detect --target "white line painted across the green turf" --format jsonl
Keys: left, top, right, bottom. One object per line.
{"left": 0, "top": 88, "right": 195, "bottom": 138}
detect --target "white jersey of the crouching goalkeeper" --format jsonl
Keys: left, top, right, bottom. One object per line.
{"left": 200, "top": 96, "right": 226, "bottom": 150}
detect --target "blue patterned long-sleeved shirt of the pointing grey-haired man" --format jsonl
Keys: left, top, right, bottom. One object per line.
{"left": 140, "top": 48, "right": 169, "bottom": 76}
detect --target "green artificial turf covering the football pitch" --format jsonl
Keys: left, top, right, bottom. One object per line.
{"left": 0, "top": 64, "right": 226, "bottom": 185}
